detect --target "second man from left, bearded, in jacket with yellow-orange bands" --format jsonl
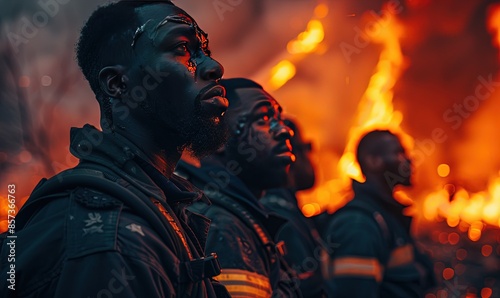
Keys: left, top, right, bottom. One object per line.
{"left": 177, "top": 79, "right": 301, "bottom": 297}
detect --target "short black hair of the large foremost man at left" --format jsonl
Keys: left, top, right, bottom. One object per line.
{"left": 76, "top": 0, "right": 174, "bottom": 104}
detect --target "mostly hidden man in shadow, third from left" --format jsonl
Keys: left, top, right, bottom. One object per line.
{"left": 261, "top": 118, "right": 330, "bottom": 298}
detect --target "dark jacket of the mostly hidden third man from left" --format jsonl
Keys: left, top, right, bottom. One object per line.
{"left": 260, "top": 189, "right": 334, "bottom": 297}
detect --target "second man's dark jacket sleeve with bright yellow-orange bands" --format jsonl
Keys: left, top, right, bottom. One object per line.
{"left": 205, "top": 214, "right": 272, "bottom": 297}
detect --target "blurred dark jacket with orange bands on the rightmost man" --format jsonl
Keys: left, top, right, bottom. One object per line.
{"left": 323, "top": 182, "right": 434, "bottom": 298}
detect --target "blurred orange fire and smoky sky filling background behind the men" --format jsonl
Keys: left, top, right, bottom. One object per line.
{"left": 0, "top": 0, "right": 500, "bottom": 298}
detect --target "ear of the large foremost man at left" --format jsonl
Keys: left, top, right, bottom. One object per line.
{"left": 99, "top": 65, "right": 128, "bottom": 98}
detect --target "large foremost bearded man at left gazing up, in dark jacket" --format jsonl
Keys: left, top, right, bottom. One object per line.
{"left": 0, "top": 1, "right": 228, "bottom": 297}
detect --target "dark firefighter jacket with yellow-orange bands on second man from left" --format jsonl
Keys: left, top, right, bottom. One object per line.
{"left": 177, "top": 162, "right": 301, "bottom": 297}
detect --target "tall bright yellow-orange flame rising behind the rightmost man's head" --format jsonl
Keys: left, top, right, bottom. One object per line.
{"left": 306, "top": 4, "right": 413, "bottom": 213}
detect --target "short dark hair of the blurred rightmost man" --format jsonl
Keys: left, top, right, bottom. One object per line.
{"left": 356, "top": 130, "right": 399, "bottom": 172}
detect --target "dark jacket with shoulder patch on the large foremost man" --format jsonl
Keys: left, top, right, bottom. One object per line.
{"left": 0, "top": 125, "right": 227, "bottom": 297}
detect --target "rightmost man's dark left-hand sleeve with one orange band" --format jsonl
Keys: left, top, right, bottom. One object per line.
{"left": 324, "top": 211, "right": 386, "bottom": 298}
